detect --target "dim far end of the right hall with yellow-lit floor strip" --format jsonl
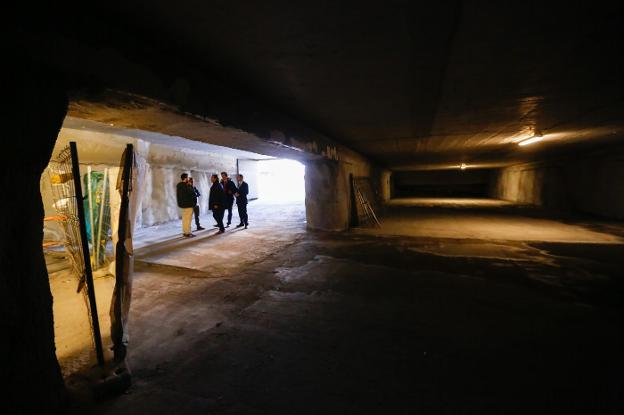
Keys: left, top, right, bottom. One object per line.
{"left": 370, "top": 163, "right": 622, "bottom": 244}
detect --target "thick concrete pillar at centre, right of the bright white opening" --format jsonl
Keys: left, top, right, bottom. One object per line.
{"left": 305, "top": 159, "right": 351, "bottom": 231}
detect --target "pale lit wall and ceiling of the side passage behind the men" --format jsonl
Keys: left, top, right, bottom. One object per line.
{"left": 41, "top": 122, "right": 246, "bottom": 236}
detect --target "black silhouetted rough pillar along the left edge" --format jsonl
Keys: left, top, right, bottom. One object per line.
{"left": 0, "top": 58, "right": 67, "bottom": 413}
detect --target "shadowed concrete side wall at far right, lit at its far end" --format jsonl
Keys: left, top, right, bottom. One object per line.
{"left": 492, "top": 147, "right": 624, "bottom": 219}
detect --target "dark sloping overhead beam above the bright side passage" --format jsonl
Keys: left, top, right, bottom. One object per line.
{"left": 17, "top": 26, "right": 376, "bottom": 167}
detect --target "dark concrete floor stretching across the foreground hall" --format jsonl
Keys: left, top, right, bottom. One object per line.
{"left": 57, "top": 203, "right": 624, "bottom": 414}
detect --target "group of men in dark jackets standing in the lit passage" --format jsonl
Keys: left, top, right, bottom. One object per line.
{"left": 176, "top": 172, "right": 249, "bottom": 238}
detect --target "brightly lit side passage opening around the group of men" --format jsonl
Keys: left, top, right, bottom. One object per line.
{"left": 40, "top": 116, "right": 305, "bottom": 377}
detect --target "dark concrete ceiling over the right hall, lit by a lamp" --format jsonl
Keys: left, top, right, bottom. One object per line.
{"left": 44, "top": 0, "right": 624, "bottom": 169}
